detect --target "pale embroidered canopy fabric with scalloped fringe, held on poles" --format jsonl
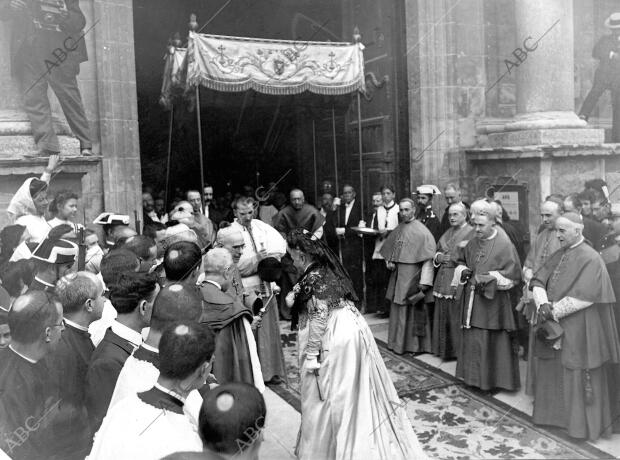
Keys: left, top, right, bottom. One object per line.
{"left": 167, "top": 32, "right": 365, "bottom": 95}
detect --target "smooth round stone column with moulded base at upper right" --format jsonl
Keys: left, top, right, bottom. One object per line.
{"left": 489, "top": 0, "right": 603, "bottom": 146}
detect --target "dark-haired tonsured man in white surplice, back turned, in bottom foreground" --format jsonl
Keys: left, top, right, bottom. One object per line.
{"left": 87, "top": 321, "right": 214, "bottom": 460}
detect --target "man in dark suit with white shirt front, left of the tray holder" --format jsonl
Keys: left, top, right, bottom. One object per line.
{"left": 332, "top": 184, "right": 363, "bottom": 306}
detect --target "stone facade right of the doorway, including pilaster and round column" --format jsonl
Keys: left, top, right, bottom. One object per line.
{"left": 406, "top": 0, "right": 620, "bottom": 237}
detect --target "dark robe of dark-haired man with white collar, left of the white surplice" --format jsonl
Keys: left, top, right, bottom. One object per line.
{"left": 86, "top": 328, "right": 135, "bottom": 434}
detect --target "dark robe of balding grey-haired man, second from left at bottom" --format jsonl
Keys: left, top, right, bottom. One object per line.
{"left": 45, "top": 323, "right": 95, "bottom": 460}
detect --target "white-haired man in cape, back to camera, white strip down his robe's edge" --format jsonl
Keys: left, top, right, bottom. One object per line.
{"left": 200, "top": 248, "right": 265, "bottom": 392}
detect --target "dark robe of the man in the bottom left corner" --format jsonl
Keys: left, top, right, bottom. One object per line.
{"left": 0, "top": 347, "right": 60, "bottom": 460}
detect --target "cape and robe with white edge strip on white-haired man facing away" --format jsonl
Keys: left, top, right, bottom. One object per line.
{"left": 200, "top": 281, "right": 264, "bottom": 390}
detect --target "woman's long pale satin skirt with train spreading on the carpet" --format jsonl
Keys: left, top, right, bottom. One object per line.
{"left": 297, "top": 301, "right": 427, "bottom": 460}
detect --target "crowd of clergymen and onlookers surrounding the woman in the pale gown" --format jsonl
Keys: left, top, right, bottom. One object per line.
{"left": 0, "top": 160, "right": 620, "bottom": 458}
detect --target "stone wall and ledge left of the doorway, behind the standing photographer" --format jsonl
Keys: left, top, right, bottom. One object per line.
{"left": 0, "top": 0, "right": 142, "bottom": 227}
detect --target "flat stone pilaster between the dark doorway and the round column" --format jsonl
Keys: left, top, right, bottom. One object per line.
{"left": 405, "top": 0, "right": 486, "bottom": 199}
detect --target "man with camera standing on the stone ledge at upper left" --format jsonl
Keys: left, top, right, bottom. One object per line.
{"left": 0, "top": 0, "right": 92, "bottom": 156}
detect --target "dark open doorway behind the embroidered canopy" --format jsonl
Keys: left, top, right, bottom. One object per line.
{"left": 134, "top": 0, "right": 350, "bottom": 205}
